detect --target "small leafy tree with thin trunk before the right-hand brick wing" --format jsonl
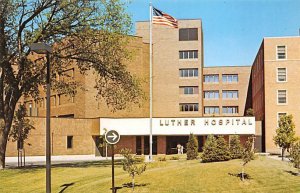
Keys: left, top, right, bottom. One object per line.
{"left": 273, "top": 115, "right": 296, "bottom": 161}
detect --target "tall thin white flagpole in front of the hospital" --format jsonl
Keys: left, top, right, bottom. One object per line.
{"left": 149, "top": 1, "right": 153, "bottom": 162}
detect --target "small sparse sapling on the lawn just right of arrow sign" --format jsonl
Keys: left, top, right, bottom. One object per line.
{"left": 120, "top": 148, "right": 147, "bottom": 190}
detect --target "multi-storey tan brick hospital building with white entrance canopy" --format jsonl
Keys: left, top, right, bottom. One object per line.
{"left": 7, "top": 19, "right": 300, "bottom": 156}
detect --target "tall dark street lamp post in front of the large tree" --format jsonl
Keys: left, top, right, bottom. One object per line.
{"left": 30, "top": 43, "right": 52, "bottom": 193}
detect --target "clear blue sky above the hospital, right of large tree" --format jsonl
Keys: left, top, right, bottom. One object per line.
{"left": 128, "top": 0, "right": 300, "bottom": 66}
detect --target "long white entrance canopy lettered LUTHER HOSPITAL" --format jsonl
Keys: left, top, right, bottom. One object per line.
{"left": 100, "top": 117, "right": 255, "bottom": 135}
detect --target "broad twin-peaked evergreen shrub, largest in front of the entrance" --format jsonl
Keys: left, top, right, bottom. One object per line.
{"left": 201, "top": 135, "right": 230, "bottom": 162}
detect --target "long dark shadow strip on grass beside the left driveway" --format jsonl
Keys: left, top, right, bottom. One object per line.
{"left": 8, "top": 160, "right": 122, "bottom": 173}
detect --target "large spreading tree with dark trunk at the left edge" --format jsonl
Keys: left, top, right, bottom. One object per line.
{"left": 0, "top": 0, "right": 142, "bottom": 169}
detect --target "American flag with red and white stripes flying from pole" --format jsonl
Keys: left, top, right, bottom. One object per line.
{"left": 152, "top": 7, "right": 178, "bottom": 28}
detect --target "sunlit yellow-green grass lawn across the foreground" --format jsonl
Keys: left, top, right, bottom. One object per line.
{"left": 0, "top": 156, "right": 300, "bottom": 193}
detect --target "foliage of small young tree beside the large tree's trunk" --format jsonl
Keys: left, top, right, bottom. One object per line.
{"left": 9, "top": 105, "right": 35, "bottom": 147}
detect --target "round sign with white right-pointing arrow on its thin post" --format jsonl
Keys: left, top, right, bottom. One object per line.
{"left": 105, "top": 130, "right": 120, "bottom": 193}
